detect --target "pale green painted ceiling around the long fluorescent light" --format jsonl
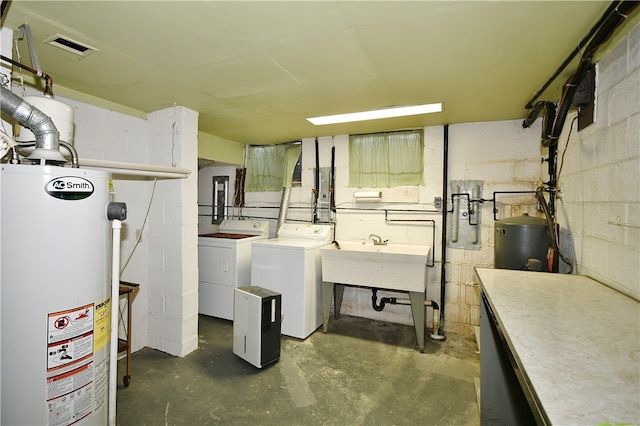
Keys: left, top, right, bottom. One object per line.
{"left": 2, "top": 0, "right": 640, "bottom": 144}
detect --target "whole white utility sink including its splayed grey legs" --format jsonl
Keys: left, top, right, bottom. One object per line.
{"left": 320, "top": 241, "right": 430, "bottom": 352}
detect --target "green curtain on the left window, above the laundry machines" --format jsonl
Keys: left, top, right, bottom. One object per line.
{"left": 244, "top": 144, "right": 302, "bottom": 192}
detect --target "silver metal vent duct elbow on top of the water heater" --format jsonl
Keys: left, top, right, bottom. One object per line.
{"left": 0, "top": 86, "right": 67, "bottom": 163}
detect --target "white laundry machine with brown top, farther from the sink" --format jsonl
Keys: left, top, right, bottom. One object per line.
{"left": 198, "top": 219, "right": 269, "bottom": 320}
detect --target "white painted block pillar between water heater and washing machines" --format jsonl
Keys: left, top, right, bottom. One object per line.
{"left": 147, "top": 107, "right": 198, "bottom": 356}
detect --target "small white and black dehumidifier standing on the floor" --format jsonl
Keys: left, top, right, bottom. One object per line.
{"left": 233, "top": 286, "right": 282, "bottom": 368}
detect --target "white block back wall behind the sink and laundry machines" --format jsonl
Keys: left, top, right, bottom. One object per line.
{"left": 209, "top": 120, "right": 548, "bottom": 334}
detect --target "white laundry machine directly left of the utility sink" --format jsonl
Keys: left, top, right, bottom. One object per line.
{"left": 251, "top": 223, "right": 333, "bottom": 339}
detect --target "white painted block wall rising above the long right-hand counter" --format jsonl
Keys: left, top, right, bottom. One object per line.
{"left": 558, "top": 22, "right": 640, "bottom": 300}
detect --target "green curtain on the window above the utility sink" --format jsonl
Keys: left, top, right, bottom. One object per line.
{"left": 349, "top": 130, "right": 424, "bottom": 188}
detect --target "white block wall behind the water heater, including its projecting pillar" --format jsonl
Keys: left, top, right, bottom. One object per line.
{"left": 3, "top": 80, "right": 198, "bottom": 356}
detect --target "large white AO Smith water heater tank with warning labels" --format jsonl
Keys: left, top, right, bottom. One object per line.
{"left": 0, "top": 164, "right": 111, "bottom": 425}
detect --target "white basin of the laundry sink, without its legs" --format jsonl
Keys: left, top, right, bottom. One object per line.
{"left": 320, "top": 241, "right": 430, "bottom": 292}
